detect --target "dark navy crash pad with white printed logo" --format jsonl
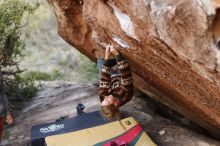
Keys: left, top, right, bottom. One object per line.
{"left": 31, "top": 111, "right": 109, "bottom": 146}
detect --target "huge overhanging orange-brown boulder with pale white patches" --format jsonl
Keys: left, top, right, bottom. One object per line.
{"left": 48, "top": 0, "right": 220, "bottom": 137}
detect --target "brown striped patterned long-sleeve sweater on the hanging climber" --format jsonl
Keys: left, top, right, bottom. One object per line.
{"left": 99, "top": 55, "right": 133, "bottom": 106}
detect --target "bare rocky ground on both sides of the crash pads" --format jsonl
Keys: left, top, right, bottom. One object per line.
{"left": 2, "top": 81, "right": 220, "bottom": 146}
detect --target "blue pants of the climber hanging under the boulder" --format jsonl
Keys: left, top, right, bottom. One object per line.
{"left": 97, "top": 58, "right": 120, "bottom": 76}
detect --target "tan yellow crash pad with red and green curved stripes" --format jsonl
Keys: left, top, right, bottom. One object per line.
{"left": 45, "top": 117, "right": 156, "bottom": 146}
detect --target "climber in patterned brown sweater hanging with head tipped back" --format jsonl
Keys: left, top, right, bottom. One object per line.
{"left": 93, "top": 45, "right": 133, "bottom": 118}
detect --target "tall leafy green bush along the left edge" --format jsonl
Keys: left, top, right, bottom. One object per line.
{"left": 0, "top": 0, "right": 38, "bottom": 113}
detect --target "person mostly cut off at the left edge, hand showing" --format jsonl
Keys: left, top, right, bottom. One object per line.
{"left": 0, "top": 74, "right": 13, "bottom": 143}
